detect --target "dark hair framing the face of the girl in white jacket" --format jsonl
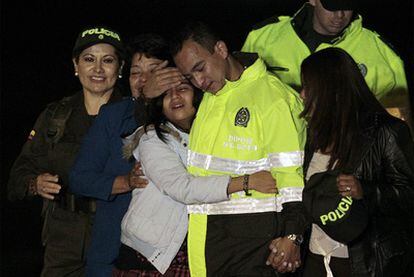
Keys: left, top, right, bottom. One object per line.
{"left": 144, "top": 84, "right": 203, "bottom": 142}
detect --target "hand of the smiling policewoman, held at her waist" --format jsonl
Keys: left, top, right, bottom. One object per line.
{"left": 32, "top": 173, "right": 62, "bottom": 200}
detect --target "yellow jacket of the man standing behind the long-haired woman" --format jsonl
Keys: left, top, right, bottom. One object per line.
{"left": 242, "top": 4, "right": 411, "bottom": 127}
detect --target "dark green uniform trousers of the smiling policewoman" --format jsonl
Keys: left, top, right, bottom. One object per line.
{"left": 41, "top": 207, "right": 93, "bottom": 277}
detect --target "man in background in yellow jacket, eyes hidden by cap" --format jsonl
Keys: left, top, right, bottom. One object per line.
{"left": 242, "top": 0, "right": 412, "bottom": 130}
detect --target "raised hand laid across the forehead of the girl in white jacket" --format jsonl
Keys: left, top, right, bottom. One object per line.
{"left": 142, "top": 61, "right": 185, "bottom": 98}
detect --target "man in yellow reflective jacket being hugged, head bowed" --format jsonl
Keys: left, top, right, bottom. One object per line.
{"left": 171, "top": 22, "right": 306, "bottom": 276}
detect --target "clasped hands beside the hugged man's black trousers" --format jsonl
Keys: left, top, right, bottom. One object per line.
{"left": 266, "top": 237, "right": 301, "bottom": 273}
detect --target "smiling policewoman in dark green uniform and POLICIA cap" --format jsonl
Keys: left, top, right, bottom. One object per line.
{"left": 8, "top": 26, "right": 125, "bottom": 277}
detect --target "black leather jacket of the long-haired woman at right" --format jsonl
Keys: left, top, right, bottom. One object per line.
{"left": 304, "top": 114, "right": 414, "bottom": 277}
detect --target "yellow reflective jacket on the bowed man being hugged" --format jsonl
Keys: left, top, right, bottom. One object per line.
{"left": 187, "top": 56, "right": 306, "bottom": 276}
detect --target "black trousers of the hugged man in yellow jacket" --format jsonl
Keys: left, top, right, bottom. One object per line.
{"left": 205, "top": 212, "right": 292, "bottom": 277}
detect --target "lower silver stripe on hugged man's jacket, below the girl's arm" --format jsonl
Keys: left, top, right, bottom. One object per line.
{"left": 187, "top": 197, "right": 282, "bottom": 215}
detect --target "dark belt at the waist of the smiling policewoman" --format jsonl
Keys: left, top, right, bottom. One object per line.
{"left": 56, "top": 192, "right": 96, "bottom": 214}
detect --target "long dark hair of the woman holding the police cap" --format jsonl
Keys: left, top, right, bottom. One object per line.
{"left": 301, "top": 47, "right": 386, "bottom": 169}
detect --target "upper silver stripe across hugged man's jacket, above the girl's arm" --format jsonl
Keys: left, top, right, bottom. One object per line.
{"left": 187, "top": 150, "right": 303, "bottom": 175}
